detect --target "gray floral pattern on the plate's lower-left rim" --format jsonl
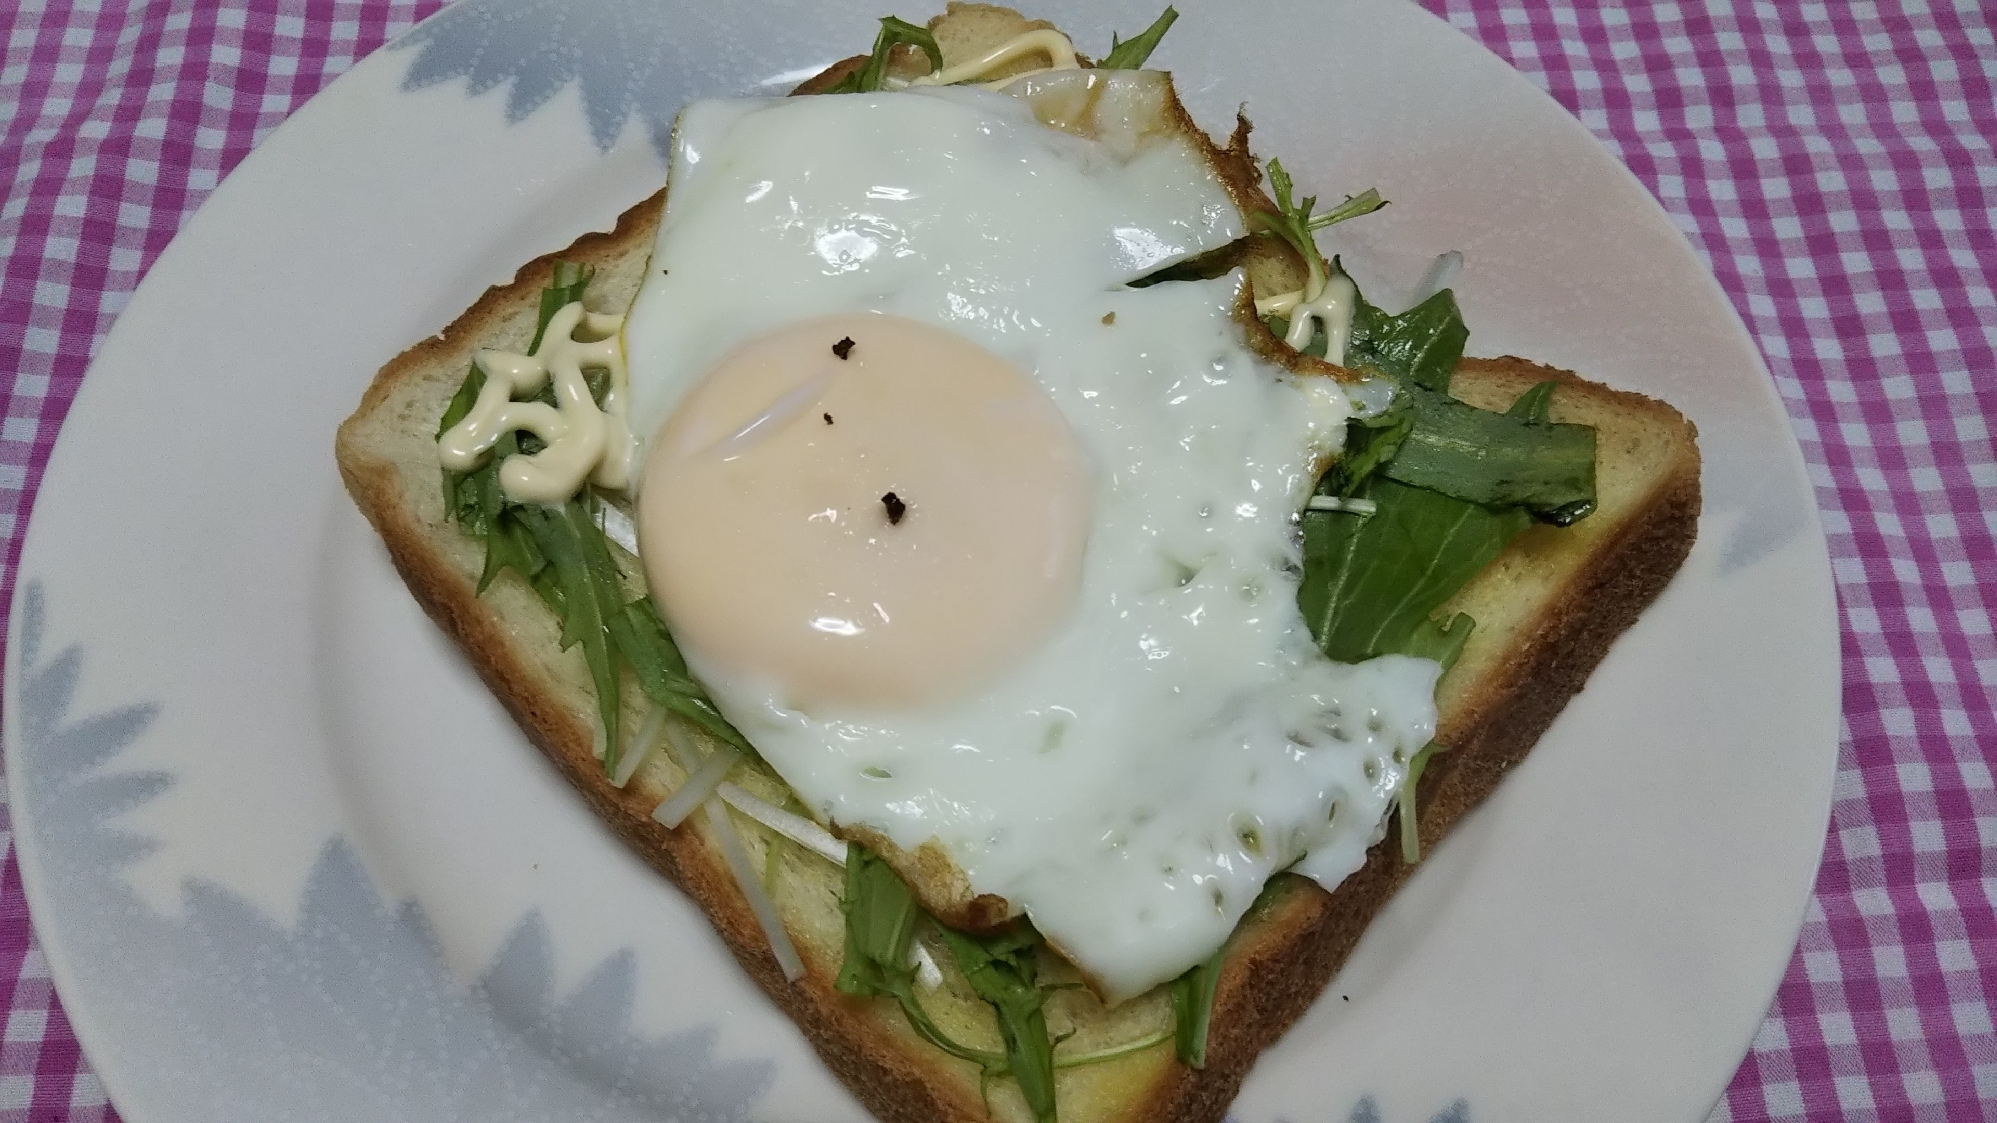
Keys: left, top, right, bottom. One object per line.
{"left": 8, "top": 581, "right": 775, "bottom": 1123}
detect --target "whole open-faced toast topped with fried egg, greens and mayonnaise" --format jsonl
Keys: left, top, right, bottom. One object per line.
{"left": 337, "top": 4, "right": 1699, "bottom": 1123}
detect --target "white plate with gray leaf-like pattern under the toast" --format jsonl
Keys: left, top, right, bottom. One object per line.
{"left": 4, "top": 0, "right": 1839, "bottom": 1123}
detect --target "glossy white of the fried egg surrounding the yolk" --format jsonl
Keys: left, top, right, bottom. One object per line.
{"left": 625, "top": 90, "right": 1438, "bottom": 999}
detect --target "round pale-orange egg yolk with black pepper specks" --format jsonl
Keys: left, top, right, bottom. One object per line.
{"left": 639, "top": 312, "right": 1090, "bottom": 707}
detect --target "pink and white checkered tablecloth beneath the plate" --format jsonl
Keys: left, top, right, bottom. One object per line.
{"left": 0, "top": 0, "right": 1997, "bottom": 1123}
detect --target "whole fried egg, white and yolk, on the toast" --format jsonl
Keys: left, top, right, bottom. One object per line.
{"left": 623, "top": 72, "right": 1438, "bottom": 1001}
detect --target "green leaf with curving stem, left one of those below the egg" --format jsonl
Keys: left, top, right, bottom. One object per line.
{"left": 833, "top": 843, "right": 1006, "bottom": 1077}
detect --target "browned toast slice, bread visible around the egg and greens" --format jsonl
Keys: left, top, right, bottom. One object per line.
{"left": 337, "top": 6, "right": 1699, "bottom": 1123}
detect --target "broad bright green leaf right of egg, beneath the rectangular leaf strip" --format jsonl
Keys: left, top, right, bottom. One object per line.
{"left": 1296, "top": 476, "right": 1532, "bottom": 663}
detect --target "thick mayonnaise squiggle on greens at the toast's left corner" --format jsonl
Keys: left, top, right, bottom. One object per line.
{"left": 437, "top": 302, "right": 637, "bottom": 504}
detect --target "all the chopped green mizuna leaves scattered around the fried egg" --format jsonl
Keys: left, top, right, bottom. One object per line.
{"left": 437, "top": 19, "right": 1596, "bottom": 1123}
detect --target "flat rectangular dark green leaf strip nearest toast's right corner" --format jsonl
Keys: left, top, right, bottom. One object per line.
{"left": 1382, "top": 384, "right": 1596, "bottom": 526}
